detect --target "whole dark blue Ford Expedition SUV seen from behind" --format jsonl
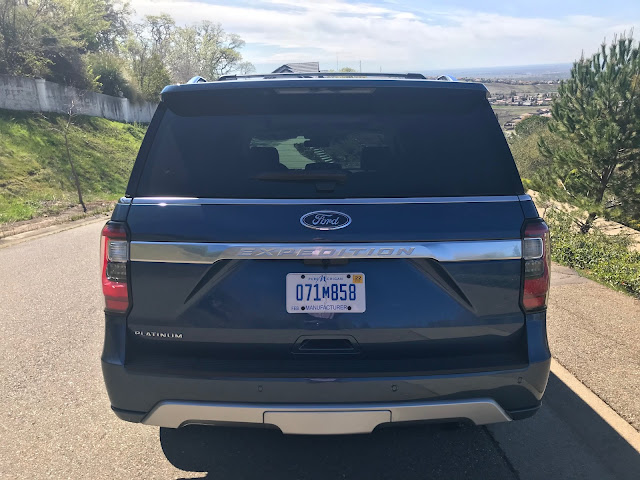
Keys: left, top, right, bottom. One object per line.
{"left": 102, "top": 75, "right": 550, "bottom": 434}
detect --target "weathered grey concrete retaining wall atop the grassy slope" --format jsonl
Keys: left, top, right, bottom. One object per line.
{"left": 0, "top": 75, "right": 157, "bottom": 123}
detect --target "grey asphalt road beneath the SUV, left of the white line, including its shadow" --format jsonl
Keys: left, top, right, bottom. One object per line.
{"left": 0, "top": 223, "right": 640, "bottom": 480}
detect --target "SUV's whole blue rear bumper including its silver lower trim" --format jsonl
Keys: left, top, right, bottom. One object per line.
{"left": 102, "top": 313, "right": 550, "bottom": 434}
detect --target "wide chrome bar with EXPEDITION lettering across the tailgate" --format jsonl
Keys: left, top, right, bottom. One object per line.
{"left": 130, "top": 239, "right": 522, "bottom": 264}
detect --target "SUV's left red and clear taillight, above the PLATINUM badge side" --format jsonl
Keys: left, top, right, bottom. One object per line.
{"left": 100, "top": 222, "right": 129, "bottom": 313}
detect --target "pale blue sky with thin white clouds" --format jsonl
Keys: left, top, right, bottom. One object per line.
{"left": 131, "top": 0, "right": 640, "bottom": 73}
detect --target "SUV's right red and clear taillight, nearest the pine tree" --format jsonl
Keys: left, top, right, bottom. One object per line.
{"left": 522, "top": 220, "right": 551, "bottom": 311}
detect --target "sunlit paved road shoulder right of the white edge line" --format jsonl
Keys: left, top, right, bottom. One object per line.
{"left": 548, "top": 266, "right": 640, "bottom": 430}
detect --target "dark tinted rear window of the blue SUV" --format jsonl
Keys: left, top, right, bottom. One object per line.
{"left": 129, "top": 89, "right": 522, "bottom": 198}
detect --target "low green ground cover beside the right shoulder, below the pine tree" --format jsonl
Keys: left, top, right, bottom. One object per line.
{"left": 545, "top": 211, "right": 640, "bottom": 297}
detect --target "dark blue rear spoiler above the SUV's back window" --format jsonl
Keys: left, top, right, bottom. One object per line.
{"left": 162, "top": 78, "right": 490, "bottom": 116}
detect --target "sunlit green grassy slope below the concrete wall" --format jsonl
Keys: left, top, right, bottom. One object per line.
{"left": 0, "top": 110, "right": 146, "bottom": 224}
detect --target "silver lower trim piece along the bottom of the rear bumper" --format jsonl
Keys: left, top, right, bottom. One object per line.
{"left": 142, "top": 398, "right": 511, "bottom": 435}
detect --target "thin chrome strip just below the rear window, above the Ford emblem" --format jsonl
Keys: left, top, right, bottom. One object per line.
{"left": 132, "top": 195, "right": 531, "bottom": 206}
